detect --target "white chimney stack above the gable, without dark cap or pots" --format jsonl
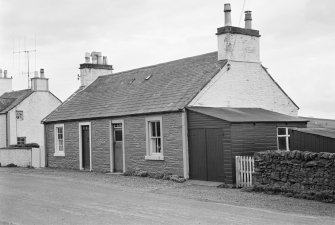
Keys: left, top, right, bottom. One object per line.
{"left": 218, "top": 33, "right": 260, "bottom": 62}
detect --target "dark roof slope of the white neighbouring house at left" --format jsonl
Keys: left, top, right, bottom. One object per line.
{"left": 0, "top": 89, "right": 33, "bottom": 114}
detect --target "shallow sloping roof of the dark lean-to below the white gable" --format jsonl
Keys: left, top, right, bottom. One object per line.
{"left": 187, "top": 106, "right": 308, "bottom": 122}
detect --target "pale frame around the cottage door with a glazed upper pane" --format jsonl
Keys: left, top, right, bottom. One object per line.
{"left": 109, "top": 119, "right": 126, "bottom": 173}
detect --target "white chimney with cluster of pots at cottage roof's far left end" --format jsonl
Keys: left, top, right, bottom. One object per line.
{"left": 79, "top": 52, "right": 113, "bottom": 86}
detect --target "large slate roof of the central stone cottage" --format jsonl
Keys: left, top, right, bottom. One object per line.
{"left": 44, "top": 52, "right": 226, "bottom": 122}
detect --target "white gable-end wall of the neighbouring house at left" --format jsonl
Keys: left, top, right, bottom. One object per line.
{"left": 9, "top": 91, "right": 61, "bottom": 167}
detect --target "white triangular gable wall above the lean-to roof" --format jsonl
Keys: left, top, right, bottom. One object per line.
{"left": 190, "top": 61, "right": 298, "bottom": 116}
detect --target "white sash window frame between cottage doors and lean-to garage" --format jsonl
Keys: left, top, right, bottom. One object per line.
{"left": 145, "top": 116, "right": 164, "bottom": 160}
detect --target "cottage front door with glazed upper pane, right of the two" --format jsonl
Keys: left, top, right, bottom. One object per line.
{"left": 112, "top": 123, "right": 123, "bottom": 172}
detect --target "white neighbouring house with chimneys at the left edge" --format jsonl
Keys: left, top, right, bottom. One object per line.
{"left": 0, "top": 69, "right": 61, "bottom": 167}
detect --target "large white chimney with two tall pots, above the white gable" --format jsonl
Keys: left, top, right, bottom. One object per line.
{"left": 216, "top": 3, "right": 260, "bottom": 62}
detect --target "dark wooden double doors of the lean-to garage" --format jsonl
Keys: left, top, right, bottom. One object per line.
{"left": 189, "top": 128, "right": 224, "bottom": 181}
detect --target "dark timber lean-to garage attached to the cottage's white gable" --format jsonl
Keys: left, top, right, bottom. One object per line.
{"left": 187, "top": 107, "right": 308, "bottom": 184}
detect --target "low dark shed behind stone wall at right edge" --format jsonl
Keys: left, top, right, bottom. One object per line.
{"left": 289, "top": 127, "right": 335, "bottom": 153}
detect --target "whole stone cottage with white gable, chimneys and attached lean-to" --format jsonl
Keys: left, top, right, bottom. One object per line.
{"left": 43, "top": 4, "right": 307, "bottom": 183}
